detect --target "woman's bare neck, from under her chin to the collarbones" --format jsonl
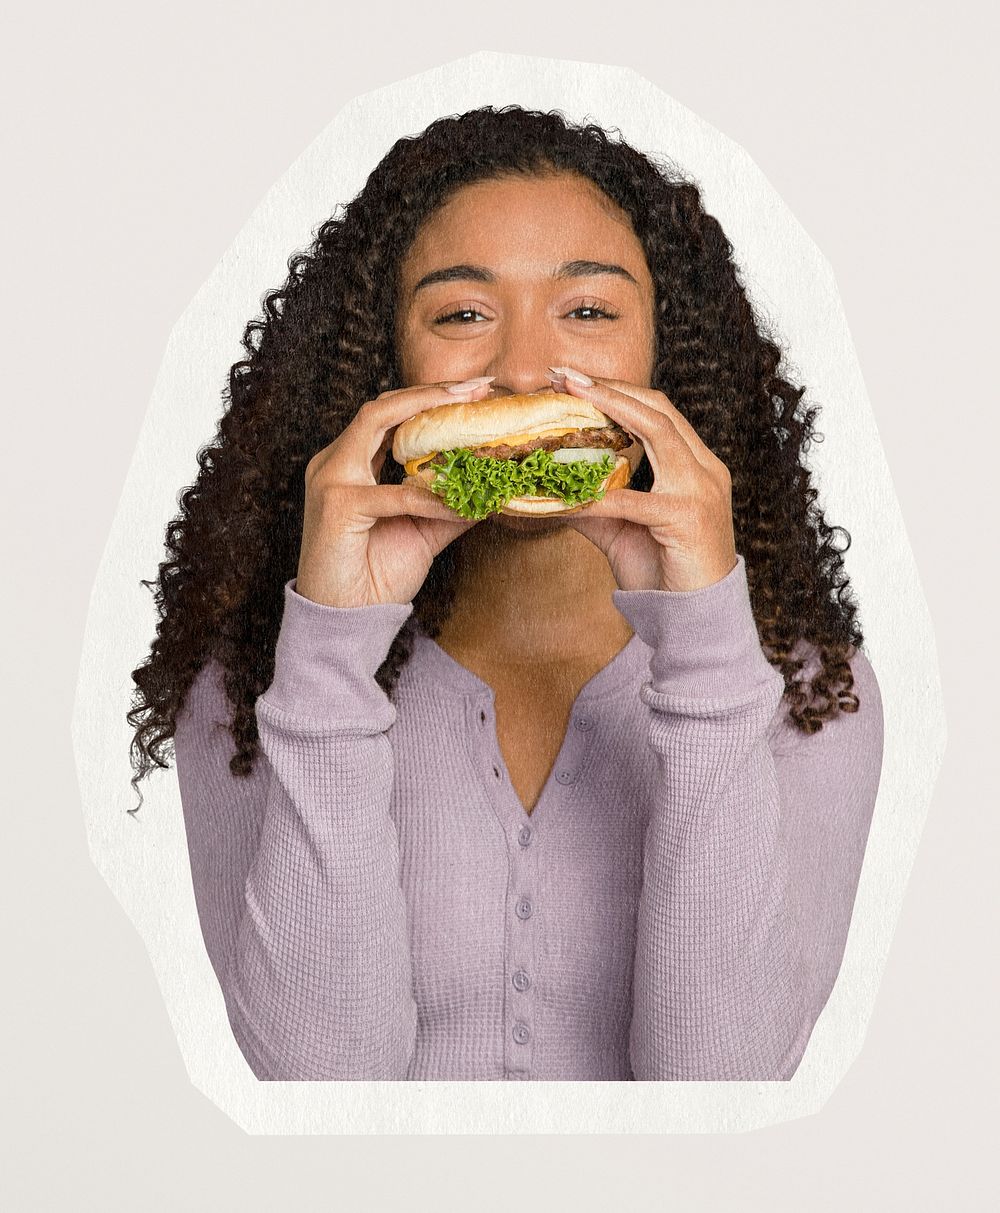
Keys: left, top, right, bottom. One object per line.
{"left": 437, "top": 518, "right": 632, "bottom": 672}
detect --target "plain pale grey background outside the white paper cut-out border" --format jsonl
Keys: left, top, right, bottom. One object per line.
{"left": 0, "top": 2, "right": 998, "bottom": 1211}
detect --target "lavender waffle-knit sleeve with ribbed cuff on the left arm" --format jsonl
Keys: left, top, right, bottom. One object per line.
{"left": 175, "top": 581, "right": 416, "bottom": 1080}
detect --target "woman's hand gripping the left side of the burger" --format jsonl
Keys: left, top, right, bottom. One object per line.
{"left": 295, "top": 382, "right": 490, "bottom": 607}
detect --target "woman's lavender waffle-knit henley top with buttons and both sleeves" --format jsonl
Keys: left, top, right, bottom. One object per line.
{"left": 175, "top": 557, "right": 882, "bottom": 1081}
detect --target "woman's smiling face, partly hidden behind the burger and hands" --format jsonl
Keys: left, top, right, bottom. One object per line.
{"left": 396, "top": 172, "right": 655, "bottom": 533}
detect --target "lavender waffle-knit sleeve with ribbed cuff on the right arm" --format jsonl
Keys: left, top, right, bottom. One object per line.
{"left": 613, "top": 556, "right": 882, "bottom": 1081}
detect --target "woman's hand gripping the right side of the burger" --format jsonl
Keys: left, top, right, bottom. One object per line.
{"left": 550, "top": 368, "right": 737, "bottom": 591}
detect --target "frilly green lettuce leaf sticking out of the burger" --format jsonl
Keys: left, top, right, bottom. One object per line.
{"left": 431, "top": 446, "right": 615, "bottom": 520}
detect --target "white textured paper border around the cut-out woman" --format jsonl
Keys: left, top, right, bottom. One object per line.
{"left": 73, "top": 51, "right": 945, "bottom": 1134}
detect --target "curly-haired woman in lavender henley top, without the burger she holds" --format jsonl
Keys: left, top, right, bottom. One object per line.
{"left": 129, "top": 107, "right": 882, "bottom": 1080}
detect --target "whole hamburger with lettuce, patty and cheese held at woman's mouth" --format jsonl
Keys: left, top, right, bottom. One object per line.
{"left": 392, "top": 391, "right": 643, "bottom": 520}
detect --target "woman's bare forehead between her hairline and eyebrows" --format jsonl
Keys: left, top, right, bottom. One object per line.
{"left": 402, "top": 173, "right": 646, "bottom": 286}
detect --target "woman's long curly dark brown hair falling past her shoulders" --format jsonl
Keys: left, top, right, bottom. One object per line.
{"left": 126, "top": 106, "right": 863, "bottom": 813}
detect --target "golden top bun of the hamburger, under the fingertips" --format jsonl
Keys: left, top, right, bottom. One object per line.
{"left": 392, "top": 392, "right": 617, "bottom": 463}
